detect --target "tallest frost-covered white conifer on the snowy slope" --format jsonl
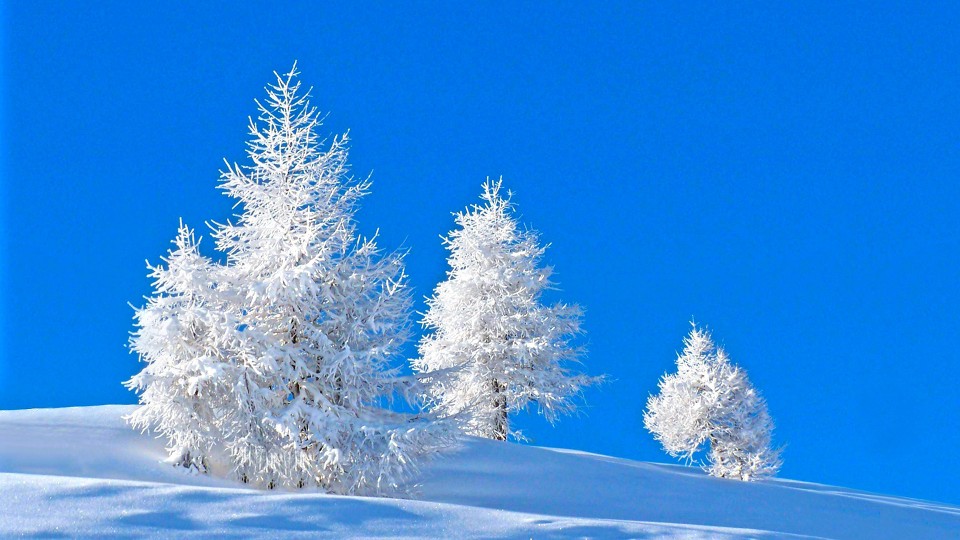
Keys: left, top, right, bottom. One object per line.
{"left": 126, "top": 67, "right": 449, "bottom": 494}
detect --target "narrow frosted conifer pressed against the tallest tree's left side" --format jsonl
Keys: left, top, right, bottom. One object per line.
{"left": 125, "top": 223, "right": 234, "bottom": 472}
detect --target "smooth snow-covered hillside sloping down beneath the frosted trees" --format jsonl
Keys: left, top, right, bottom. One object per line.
{"left": 0, "top": 406, "right": 960, "bottom": 539}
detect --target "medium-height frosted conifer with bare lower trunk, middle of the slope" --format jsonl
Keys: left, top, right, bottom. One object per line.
{"left": 414, "top": 180, "right": 599, "bottom": 440}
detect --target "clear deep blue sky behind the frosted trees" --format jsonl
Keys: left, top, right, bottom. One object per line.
{"left": 0, "top": 1, "right": 960, "bottom": 503}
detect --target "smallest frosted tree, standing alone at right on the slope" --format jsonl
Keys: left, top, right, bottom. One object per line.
{"left": 643, "top": 325, "right": 781, "bottom": 480}
